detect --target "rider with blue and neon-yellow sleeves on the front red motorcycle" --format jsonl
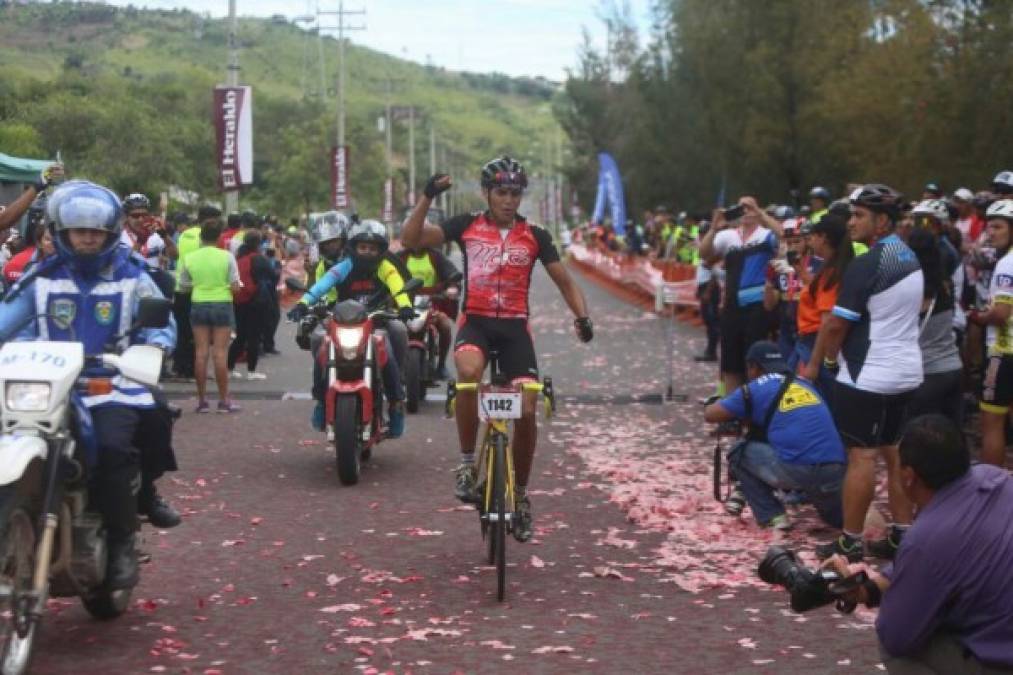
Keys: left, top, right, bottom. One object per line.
{"left": 288, "top": 220, "right": 414, "bottom": 438}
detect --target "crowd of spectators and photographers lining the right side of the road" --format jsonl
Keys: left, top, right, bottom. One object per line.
{"left": 571, "top": 171, "right": 1013, "bottom": 673}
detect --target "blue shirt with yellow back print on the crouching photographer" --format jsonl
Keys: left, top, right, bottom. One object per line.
{"left": 721, "top": 373, "right": 846, "bottom": 464}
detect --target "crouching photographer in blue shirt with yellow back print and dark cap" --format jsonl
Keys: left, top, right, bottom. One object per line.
{"left": 704, "top": 341, "right": 847, "bottom": 529}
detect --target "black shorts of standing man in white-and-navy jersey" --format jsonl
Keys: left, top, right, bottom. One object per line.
{"left": 833, "top": 381, "right": 915, "bottom": 448}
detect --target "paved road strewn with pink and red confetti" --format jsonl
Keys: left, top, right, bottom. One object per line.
{"left": 27, "top": 263, "right": 878, "bottom": 674}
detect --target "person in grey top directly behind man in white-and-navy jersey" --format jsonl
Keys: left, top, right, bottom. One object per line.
{"left": 908, "top": 227, "right": 963, "bottom": 429}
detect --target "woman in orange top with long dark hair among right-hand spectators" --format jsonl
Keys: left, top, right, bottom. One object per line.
{"left": 789, "top": 211, "right": 855, "bottom": 402}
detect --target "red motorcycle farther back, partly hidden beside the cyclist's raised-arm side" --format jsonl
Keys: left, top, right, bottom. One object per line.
{"left": 404, "top": 275, "right": 460, "bottom": 413}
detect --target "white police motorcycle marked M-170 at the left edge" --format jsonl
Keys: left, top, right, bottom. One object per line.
{"left": 0, "top": 298, "right": 171, "bottom": 675}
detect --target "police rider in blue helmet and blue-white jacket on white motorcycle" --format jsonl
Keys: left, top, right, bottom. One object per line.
{"left": 0, "top": 180, "right": 175, "bottom": 590}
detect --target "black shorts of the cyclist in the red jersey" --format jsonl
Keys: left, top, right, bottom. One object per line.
{"left": 454, "top": 314, "right": 538, "bottom": 380}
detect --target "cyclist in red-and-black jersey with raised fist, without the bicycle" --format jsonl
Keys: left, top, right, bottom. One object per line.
{"left": 401, "top": 156, "right": 594, "bottom": 541}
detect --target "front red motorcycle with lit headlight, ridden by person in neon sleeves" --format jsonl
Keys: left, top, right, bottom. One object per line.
{"left": 289, "top": 280, "right": 421, "bottom": 485}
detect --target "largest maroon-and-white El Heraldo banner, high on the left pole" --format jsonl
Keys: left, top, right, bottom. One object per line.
{"left": 214, "top": 86, "right": 253, "bottom": 193}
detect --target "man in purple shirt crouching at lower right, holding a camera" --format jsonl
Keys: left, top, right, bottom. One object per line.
{"left": 828, "top": 415, "right": 1013, "bottom": 674}
